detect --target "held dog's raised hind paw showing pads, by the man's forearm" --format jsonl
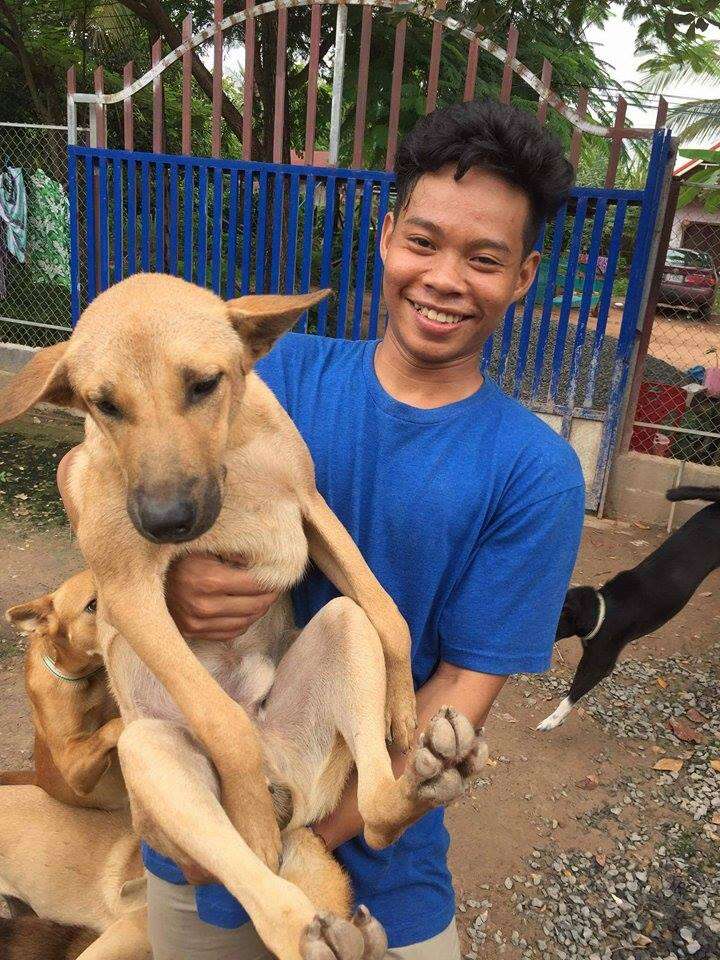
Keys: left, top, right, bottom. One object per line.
{"left": 405, "top": 707, "right": 488, "bottom": 807}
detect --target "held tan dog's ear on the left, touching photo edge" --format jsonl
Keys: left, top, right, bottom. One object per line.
{"left": 0, "top": 340, "right": 82, "bottom": 423}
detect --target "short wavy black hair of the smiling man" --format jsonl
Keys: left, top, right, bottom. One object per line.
{"left": 395, "top": 100, "right": 574, "bottom": 255}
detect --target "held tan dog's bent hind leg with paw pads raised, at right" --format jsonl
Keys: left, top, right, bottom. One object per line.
{"left": 262, "top": 597, "right": 486, "bottom": 847}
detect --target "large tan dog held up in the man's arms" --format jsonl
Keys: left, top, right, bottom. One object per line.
{"left": 0, "top": 275, "right": 482, "bottom": 960}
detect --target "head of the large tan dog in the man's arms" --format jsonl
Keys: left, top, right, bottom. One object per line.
{"left": 0, "top": 274, "right": 330, "bottom": 543}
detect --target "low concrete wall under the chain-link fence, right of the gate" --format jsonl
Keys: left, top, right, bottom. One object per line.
{"left": 605, "top": 452, "right": 720, "bottom": 528}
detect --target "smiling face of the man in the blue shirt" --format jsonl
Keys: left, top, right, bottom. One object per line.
{"left": 380, "top": 165, "right": 540, "bottom": 366}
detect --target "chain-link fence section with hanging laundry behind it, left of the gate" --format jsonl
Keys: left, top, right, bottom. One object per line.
{"left": 0, "top": 123, "right": 79, "bottom": 347}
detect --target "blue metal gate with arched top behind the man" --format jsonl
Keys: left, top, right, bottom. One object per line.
{"left": 63, "top": 0, "right": 672, "bottom": 510}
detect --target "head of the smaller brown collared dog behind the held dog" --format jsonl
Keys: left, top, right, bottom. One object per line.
{"left": 5, "top": 570, "right": 101, "bottom": 675}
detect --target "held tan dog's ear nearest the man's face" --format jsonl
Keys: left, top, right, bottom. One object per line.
{"left": 227, "top": 290, "right": 331, "bottom": 371}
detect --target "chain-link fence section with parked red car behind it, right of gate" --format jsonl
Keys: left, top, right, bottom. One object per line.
{"left": 630, "top": 187, "right": 720, "bottom": 466}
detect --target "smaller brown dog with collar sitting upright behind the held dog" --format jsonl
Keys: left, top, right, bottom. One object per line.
{"left": 0, "top": 570, "right": 128, "bottom": 810}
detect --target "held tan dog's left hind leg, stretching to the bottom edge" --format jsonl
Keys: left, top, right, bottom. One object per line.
{"left": 118, "top": 720, "right": 372, "bottom": 960}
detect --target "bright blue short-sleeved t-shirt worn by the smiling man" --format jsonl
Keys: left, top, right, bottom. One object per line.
{"left": 145, "top": 334, "right": 585, "bottom": 947}
